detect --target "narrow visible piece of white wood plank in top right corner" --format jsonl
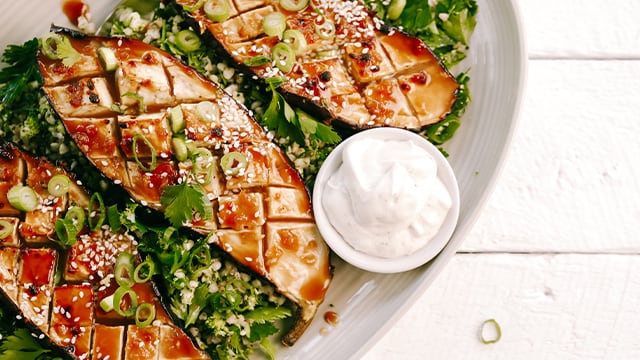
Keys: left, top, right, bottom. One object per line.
{"left": 517, "top": 0, "right": 640, "bottom": 59}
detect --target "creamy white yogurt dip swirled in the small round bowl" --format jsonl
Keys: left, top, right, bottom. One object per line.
{"left": 322, "top": 138, "right": 452, "bottom": 258}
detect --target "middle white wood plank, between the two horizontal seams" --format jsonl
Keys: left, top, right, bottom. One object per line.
{"left": 461, "top": 61, "right": 640, "bottom": 253}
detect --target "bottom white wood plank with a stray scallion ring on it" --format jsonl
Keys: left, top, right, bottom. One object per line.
{"left": 364, "top": 254, "right": 640, "bottom": 360}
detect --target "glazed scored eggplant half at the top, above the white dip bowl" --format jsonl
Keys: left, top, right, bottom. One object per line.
{"left": 176, "top": 0, "right": 459, "bottom": 130}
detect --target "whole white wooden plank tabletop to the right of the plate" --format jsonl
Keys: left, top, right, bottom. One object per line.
{"left": 365, "top": 0, "right": 640, "bottom": 360}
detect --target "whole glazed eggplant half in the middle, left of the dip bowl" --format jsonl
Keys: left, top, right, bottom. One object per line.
{"left": 39, "top": 29, "right": 332, "bottom": 345}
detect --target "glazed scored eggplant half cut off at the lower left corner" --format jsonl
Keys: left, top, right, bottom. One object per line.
{"left": 0, "top": 139, "right": 208, "bottom": 359}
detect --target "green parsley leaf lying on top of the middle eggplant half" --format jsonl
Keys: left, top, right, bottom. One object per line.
{"left": 160, "top": 182, "right": 213, "bottom": 227}
